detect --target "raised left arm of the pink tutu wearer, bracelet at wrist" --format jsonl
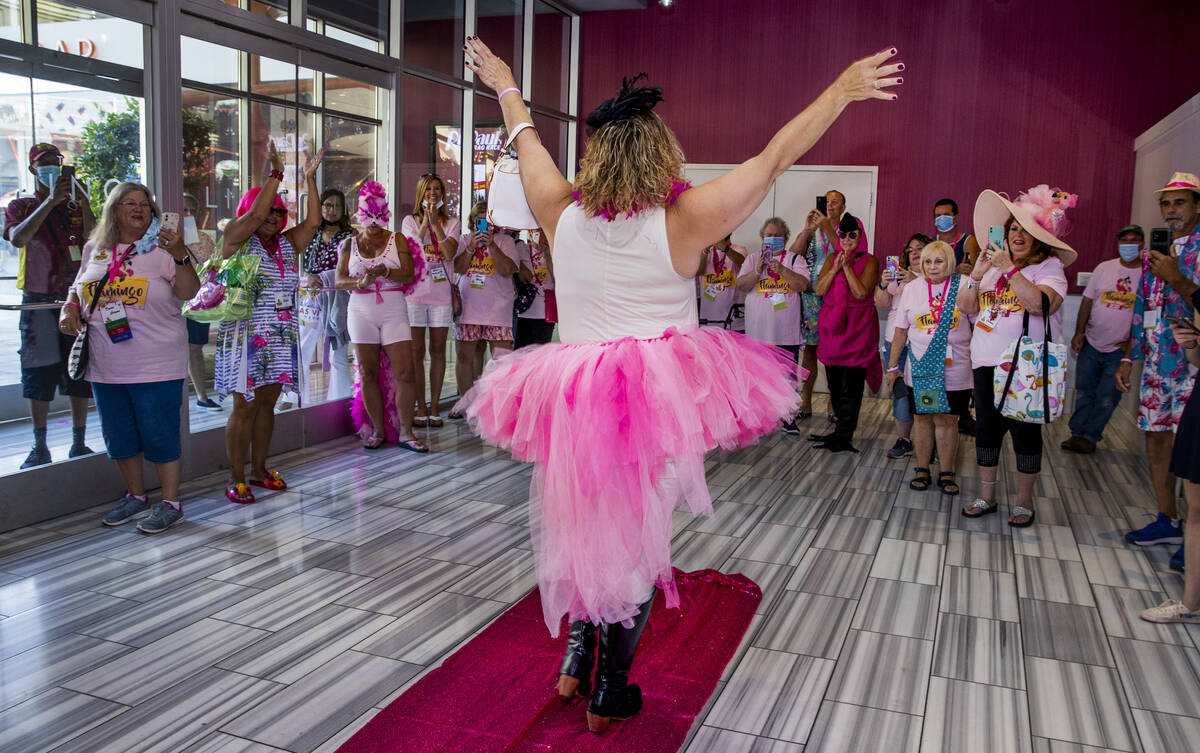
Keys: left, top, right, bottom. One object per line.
{"left": 462, "top": 37, "right": 573, "bottom": 247}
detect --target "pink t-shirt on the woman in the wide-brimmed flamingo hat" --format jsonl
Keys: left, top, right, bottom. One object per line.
{"left": 971, "top": 257, "right": 1067, "bottom": 368}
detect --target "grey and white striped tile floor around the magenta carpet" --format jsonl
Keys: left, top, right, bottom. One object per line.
{"left": 0, "top": 398, "right": 1200, "bottom": 753}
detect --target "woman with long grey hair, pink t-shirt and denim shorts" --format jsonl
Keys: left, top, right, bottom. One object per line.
{"left": 59, "top": 182, "right": 200, "bottom": 534}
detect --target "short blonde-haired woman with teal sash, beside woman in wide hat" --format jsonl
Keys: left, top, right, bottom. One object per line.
{"left": 884, "top": 241, "right": 972, "bottom": 496}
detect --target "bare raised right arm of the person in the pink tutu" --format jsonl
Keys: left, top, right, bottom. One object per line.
{"left": 667, "top": 48, "right": 904, "bottom": 261}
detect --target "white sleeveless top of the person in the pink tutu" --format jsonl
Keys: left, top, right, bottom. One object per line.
{"left": 553, "top": 203, "right": 698, "bottom": 344}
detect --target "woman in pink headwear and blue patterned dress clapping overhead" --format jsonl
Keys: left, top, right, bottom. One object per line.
{"left": 215, "top": 140, "right": 324, "bottom": 505}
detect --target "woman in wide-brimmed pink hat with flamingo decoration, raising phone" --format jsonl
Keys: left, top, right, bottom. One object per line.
{"left": 959, "top": 189, "right": 1079, "bottom": 528}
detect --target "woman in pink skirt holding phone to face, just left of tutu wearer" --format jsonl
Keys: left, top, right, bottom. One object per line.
{"left": 454, "top": 201, "right": 520, "bottom": 394}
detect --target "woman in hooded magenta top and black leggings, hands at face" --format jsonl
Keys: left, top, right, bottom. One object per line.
{"left": 809, "top": 212, "right": 883, "bottom": 452}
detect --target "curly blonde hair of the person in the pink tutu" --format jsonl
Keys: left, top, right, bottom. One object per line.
{"left": 575, "top": 112, "right": 684, "bottom": 217}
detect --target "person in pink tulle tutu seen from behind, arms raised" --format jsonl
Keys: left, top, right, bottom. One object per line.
{"left": 460, "top": 37, "right": 904, "bottom": 731}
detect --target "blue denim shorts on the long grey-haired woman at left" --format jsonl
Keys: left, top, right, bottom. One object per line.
{"left": 91, "top": 379, "right": 184, "bottom": 463}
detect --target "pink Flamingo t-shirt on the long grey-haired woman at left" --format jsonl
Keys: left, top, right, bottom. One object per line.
{"left": 74, "top": 242, "right": 187, "bottom": 385}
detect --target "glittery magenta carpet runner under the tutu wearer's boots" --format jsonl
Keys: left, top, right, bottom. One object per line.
{"left": 338, "top": 570, "right": 762, "bottom": 753}
